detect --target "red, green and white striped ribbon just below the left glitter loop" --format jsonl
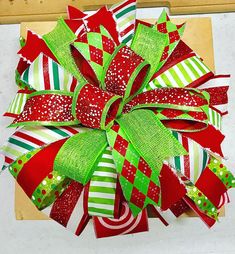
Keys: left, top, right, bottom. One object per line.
{"left": 0, "top": 126, "right": 87, "bottom": 169}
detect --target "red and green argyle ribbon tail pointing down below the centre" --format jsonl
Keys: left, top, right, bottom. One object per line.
{"left": 107, "top": 125, "right": 160, "bottom": 217}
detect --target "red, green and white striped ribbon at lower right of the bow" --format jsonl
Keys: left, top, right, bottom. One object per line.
{"left": 168, "top": 131, "right": 209, "bottom": 183}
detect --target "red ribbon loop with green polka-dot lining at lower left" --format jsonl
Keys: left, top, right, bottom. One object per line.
{"left": 9, "top": 138, "right": 70, "bottom": 210}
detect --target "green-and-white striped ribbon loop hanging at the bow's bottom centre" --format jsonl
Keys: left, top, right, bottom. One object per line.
{"left": 88, "top": 147, "right": 117, "bottom": 218}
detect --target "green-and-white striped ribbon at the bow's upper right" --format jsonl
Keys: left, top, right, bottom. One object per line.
{"left": 144, "top": 56, "right": 210, "bottom": 91}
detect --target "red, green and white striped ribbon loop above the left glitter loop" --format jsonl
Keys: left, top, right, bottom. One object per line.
{"left": 21, "top": 54, "right": 77, "bottom": 91}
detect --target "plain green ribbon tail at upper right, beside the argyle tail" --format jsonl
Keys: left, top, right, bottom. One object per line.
{"left": 131, "top": 24, "right": 168, "bottom": 84}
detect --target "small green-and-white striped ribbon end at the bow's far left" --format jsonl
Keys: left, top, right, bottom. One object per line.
{"left": 6, "top": 92, "right": 28, "bottom": 115}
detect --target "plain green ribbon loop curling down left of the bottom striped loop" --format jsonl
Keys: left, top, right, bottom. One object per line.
{"left": 54, "top": 130, "right": 108, "bottom": 185}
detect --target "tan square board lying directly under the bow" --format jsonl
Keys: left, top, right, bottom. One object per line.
{"left": 15, "top": 18, "right": 224, "bottom": 220}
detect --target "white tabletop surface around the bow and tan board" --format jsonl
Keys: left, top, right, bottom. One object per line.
{"left": 0, "top": 8, "right": 235, "bottom": 254}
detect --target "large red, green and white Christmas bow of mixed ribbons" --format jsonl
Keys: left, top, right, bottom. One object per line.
{"left": 1, "top": 0, "right": 234, "bottom": 238}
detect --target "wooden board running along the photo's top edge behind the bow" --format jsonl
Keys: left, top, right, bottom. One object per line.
{"left": 0, "top": 0, "right": 235, "bottom": 24}
